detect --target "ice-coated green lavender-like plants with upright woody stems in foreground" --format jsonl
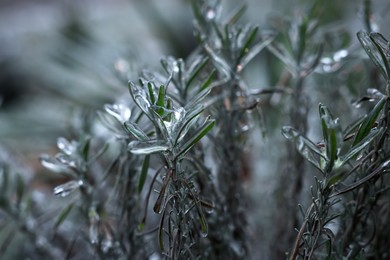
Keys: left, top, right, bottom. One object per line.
{"left": 0, "top": 0, "right": 390, "bottom": 259}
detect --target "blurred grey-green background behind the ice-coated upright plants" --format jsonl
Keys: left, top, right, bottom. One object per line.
{"left": 0, "top": 0, "right": 390, "bottom": 259}
